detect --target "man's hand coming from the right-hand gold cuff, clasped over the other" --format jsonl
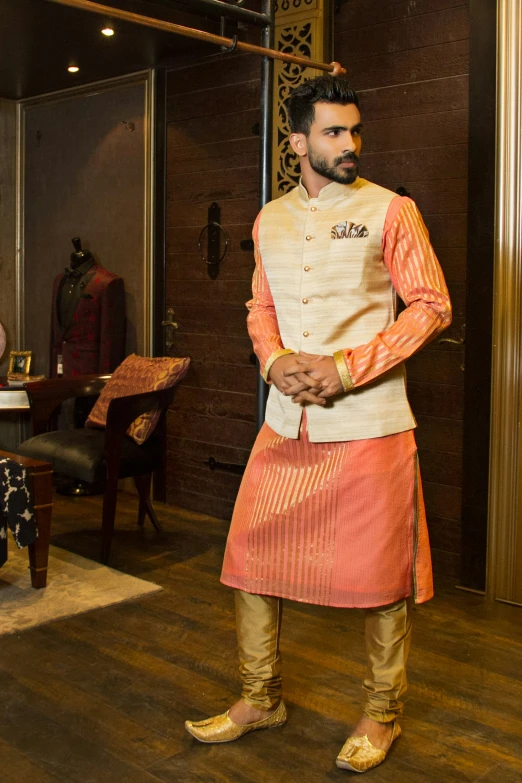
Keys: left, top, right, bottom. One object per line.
{"left": 282, "top": 351, "right": 343, "bottom": 405}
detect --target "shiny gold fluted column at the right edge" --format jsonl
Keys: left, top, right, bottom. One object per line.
{"left": 486, "top": 0, "right": 522, "bottom": 604}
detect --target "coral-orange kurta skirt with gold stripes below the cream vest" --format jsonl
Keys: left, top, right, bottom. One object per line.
{"left": 221, "top": 416, "right": 433, "bottom": 607}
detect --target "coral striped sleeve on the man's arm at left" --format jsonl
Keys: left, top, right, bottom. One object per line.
{"left": 246, "top": 213, "right": 293, "bottom": 381}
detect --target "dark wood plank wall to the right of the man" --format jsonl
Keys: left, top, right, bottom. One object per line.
{"left": 335, "top": 0, "right": 469, "bottom": 577}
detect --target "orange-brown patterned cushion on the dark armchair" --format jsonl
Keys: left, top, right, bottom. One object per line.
{"left": 85, "top": 353, "right": 190, "bottom": 445}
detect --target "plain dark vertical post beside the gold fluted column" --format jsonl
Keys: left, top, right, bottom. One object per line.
{"left": 460, "top": 0, "right": 497, "bottom": 591}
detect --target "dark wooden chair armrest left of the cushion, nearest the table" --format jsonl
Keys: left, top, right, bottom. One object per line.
{"left": 24, "top": 375, "right": 111, "bottom": 435}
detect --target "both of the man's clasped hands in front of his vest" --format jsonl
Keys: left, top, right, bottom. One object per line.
{"left": 268, "top": 351, "right": 343, "bottom": 405}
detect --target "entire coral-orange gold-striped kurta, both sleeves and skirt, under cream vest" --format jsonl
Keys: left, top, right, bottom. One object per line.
{"left": 221, "top": 197, "right": 451, "bottom": 607}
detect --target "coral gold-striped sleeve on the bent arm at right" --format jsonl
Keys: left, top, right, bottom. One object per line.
{"left": 336, "top": 198, "right": 451, "bottom": 391}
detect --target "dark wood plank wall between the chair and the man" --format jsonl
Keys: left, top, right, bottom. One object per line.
{"left": 166, "top": 55, "right": 261, "bottom": 518}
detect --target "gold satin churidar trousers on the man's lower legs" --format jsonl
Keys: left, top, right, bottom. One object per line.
{"left": 235, "top": 590, "right": 412, "bottom": 723}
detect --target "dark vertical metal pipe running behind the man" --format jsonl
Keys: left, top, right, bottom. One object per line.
{"left": 256, "top": 0, "right": 274, "bottom": 430}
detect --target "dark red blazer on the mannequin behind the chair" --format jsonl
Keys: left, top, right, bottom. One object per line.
{"left": 50, "top": 264, "right": 125, "bottom": 378}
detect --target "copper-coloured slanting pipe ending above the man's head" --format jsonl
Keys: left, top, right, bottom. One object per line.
{"left": 43, "top": 0, "right": 346, "bottom": 76}
